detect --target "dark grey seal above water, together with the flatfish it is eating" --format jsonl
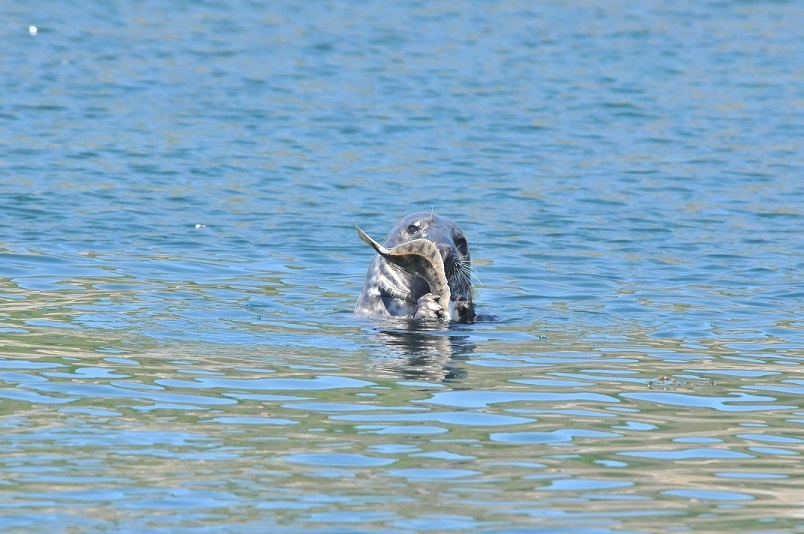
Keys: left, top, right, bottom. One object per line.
{"left": 355, "top": 212, "right": 476, "bottom": 323}
